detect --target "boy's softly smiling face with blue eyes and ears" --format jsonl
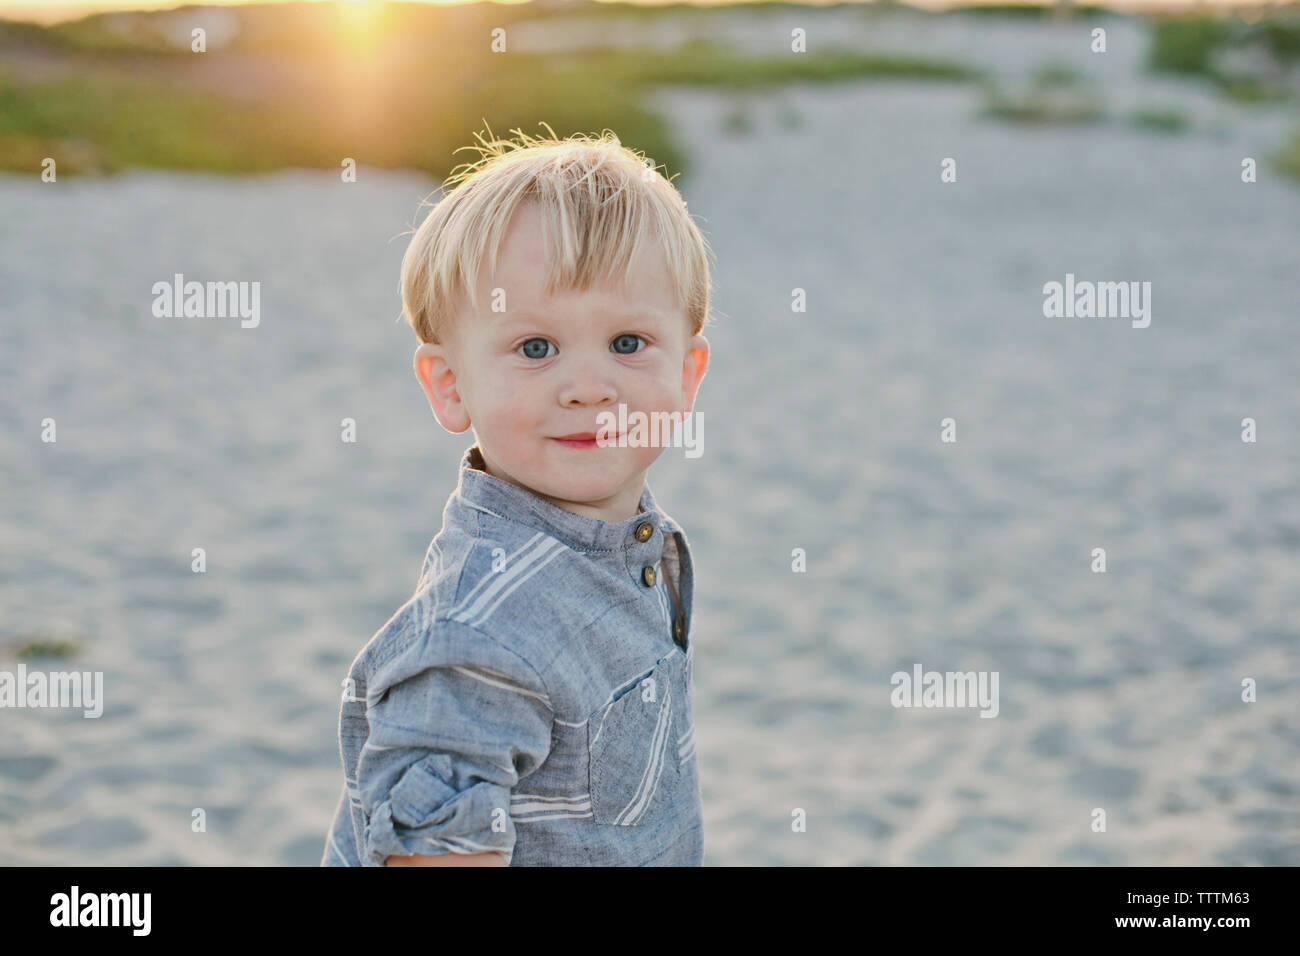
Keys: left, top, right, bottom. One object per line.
{"left": 415, "top": 203, "right": 709, "bottom": 522}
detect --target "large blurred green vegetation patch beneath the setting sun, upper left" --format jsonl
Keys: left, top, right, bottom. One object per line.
{"left": 0, "top": 4, "right": 976, "bottom": 178}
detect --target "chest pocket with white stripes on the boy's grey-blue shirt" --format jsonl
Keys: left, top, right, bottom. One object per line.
{"left": 586, "top": 650, "right": 685, "bottom": 826}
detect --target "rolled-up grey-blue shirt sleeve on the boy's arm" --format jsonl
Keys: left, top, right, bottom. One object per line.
{"left": 356, "top": 620, "right": 554, "bottom": 866}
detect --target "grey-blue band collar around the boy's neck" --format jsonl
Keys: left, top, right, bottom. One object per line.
{"left": 454, "top": 444, "right": 680, "bottom": 551}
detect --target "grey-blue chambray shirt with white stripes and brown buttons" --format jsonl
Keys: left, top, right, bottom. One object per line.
{"left": 321, "top": 445, "right": 703, "bottom": 866}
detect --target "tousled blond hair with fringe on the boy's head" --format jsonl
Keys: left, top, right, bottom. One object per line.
{"left": 400, "top": 124, "right": 712, "bottom": 345}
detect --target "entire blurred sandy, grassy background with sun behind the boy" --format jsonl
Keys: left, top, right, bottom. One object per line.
{"left": 0, "top": 0, "right": 1300, "bottom": 865}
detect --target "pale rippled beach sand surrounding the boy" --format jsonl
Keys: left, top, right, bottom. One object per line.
{"left": 0, "top": 9, "right": 1300, "bottom": 865}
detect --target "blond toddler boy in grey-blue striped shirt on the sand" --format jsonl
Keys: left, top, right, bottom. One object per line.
{"left": 321, "top": 130, "right": 710, "bottom": 866}
